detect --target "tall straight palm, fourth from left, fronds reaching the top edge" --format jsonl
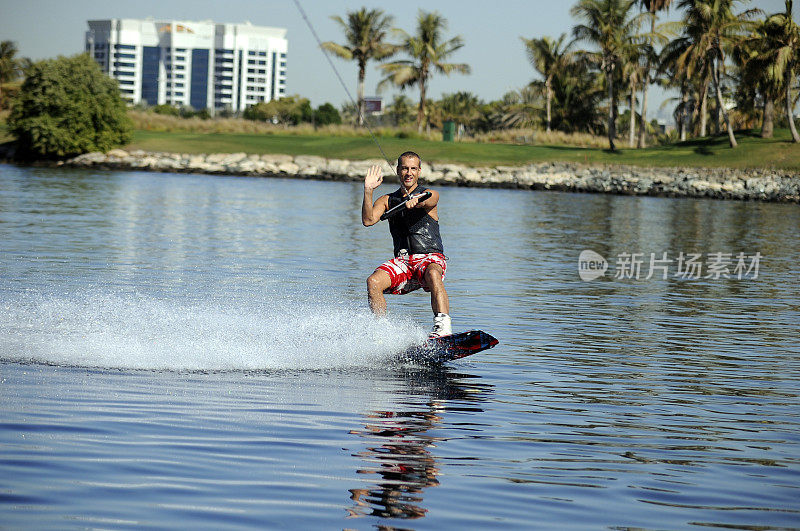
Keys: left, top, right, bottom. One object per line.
{"left": 570, "top": 0, "right": 641, "bottom": 151}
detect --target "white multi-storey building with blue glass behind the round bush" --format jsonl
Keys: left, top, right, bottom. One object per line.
{"left": 86, "top": 19, "right": 288, "bottom": 113}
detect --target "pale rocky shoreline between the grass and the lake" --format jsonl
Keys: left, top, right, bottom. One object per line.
{"left": 6, "top": 149, "right": 800, "bottom": 203}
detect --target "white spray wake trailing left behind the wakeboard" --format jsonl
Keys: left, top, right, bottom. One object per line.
{"left": 0, "top": 293, "right": 432, "bottom": 371}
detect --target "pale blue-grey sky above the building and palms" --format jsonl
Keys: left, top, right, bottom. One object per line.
{"left": 0, "top": 0, "right": 800, "bottom": 118}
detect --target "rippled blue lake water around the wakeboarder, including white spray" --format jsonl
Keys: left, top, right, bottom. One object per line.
{"left": 0, "top": 165, "right": 800, "bottom": 529}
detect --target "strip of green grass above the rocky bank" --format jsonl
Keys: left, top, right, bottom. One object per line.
{"left": 126, "top": 129, "right": 800, "bottom": 170}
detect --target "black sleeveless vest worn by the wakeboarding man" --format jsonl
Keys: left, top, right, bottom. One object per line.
{"left": 389, "top": 186, "right": 444, "bottom": 256}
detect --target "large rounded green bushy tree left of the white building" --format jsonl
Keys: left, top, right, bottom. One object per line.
{"left": 8, "top": 54, "right": 133, "bottom": 157}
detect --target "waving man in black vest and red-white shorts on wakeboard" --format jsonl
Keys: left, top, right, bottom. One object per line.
{"left": 361, "top": 151, "right": 453, "bottom": 337}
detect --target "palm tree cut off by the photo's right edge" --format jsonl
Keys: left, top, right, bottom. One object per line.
{"left": 755, "top": 0, "right": 800, "bottom": 143}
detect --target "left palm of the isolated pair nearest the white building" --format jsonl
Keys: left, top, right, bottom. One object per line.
{"left": 322, "top": 7, "right": 397, "bottom": 125}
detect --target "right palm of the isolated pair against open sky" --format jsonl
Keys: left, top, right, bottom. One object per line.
{"left": 378, "top": 10, "right": 470, "bottom": 132}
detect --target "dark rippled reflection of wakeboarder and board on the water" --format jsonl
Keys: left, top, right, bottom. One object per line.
{"left": 347, "top": 368, "right": 492, "bottom": 519}
